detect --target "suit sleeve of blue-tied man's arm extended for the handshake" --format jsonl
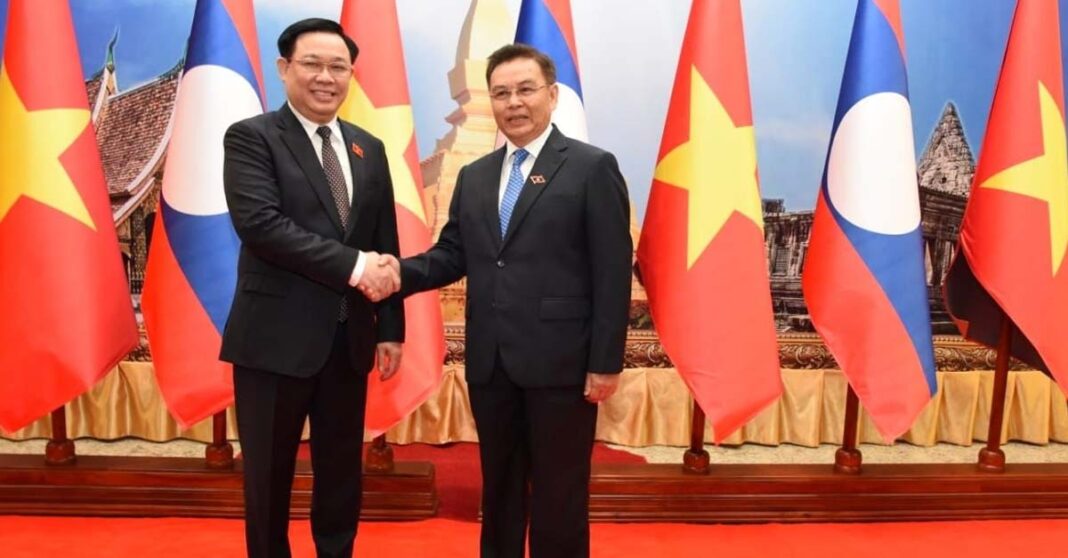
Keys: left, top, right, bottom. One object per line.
{"left": 401, "top": 167, "right": 467, "bottom": 296}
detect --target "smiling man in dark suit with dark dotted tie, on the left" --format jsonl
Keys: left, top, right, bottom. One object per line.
{"left": 221, "top": 19, "right": 404, "bottom": 557}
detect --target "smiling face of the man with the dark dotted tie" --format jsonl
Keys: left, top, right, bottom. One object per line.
{"left": 276, "top": 32, "right": 352, "bottom": 124}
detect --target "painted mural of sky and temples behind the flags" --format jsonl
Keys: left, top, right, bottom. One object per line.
{"left": 0, "top": 0, "right": 1068, "bottom": 334}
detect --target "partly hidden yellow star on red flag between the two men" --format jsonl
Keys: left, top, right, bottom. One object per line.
{"left": 340, "top": 79, "right": 426, "bottom": 224}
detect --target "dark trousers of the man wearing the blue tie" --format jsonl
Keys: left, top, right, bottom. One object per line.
{"left": 468, "top": 360, "right": 597, "bottom": 558}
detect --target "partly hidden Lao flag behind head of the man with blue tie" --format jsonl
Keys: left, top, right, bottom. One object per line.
{"left": 516, "top": 0, "right": 590, "bottom": 141}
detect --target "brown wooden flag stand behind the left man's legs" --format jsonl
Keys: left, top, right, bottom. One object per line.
{"left": 0, "top": 408, "right": 438, "bottom": 521}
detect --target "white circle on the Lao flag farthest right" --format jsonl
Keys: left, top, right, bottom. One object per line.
{"left": 827, "top": 93, "right": 920, "bottom": 234}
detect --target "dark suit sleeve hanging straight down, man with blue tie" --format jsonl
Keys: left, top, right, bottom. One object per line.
{"left": 585, "top": 153, "right": 633, "bottom": 374}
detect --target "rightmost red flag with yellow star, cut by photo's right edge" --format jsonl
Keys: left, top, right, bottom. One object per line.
{"left": 945, "top": 0, "right": 1068, "bottom": 382}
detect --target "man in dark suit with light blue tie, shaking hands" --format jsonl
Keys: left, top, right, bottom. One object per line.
{"left": 401, "top": 45, "right": 631, "bottom": 558}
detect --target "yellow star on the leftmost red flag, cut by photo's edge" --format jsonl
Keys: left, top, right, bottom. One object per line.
{"left": 0, "top": 68, "right": 96, "bottom": 231}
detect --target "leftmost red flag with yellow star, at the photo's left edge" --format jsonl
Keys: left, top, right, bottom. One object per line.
{"left": 0, "top": 0, "right": 138, "bottom": 432}
